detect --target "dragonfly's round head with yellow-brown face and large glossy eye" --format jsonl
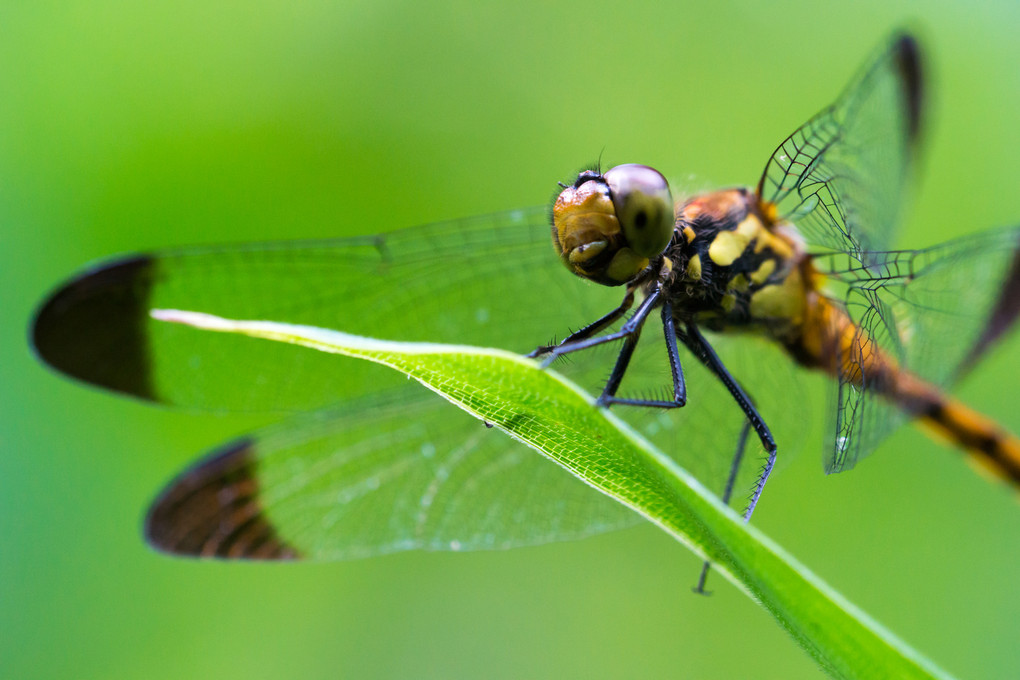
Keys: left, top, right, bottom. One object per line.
{"left": 553, "top": 164, "right": 674, "bottom": 285}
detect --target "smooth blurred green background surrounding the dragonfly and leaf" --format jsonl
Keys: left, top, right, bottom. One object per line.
{"left": 0, "top": 0, "right": 1020, "bottom": 678}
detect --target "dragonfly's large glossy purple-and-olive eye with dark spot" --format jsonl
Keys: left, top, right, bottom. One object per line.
{"left": 604, "top": 163, "right": 674, "bottom": 258}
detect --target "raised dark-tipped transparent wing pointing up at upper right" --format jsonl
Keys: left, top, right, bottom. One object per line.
{"left": 758, "top": 36, "right": 922, "bottom": 259}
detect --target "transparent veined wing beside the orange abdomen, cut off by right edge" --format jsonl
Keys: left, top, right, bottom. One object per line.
{"left": 818, "top": 227, "right": 1020, "bottom": 472}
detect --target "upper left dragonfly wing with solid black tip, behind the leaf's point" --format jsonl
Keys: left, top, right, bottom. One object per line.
{"left": 34, "top": 204, "right": 620, "bottom": 411}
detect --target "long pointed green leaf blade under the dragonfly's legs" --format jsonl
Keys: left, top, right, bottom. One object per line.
{"left": 152, "top": 310, "right": 949, "bottom": 679}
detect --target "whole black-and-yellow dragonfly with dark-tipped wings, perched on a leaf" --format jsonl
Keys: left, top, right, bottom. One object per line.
{"left": 32, "top": 35, "right": 1020, "bottom": 561}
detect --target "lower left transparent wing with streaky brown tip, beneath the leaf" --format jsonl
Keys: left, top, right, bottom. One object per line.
{"left": 146, "top": 393, "right": 641, "bottom": 561}
